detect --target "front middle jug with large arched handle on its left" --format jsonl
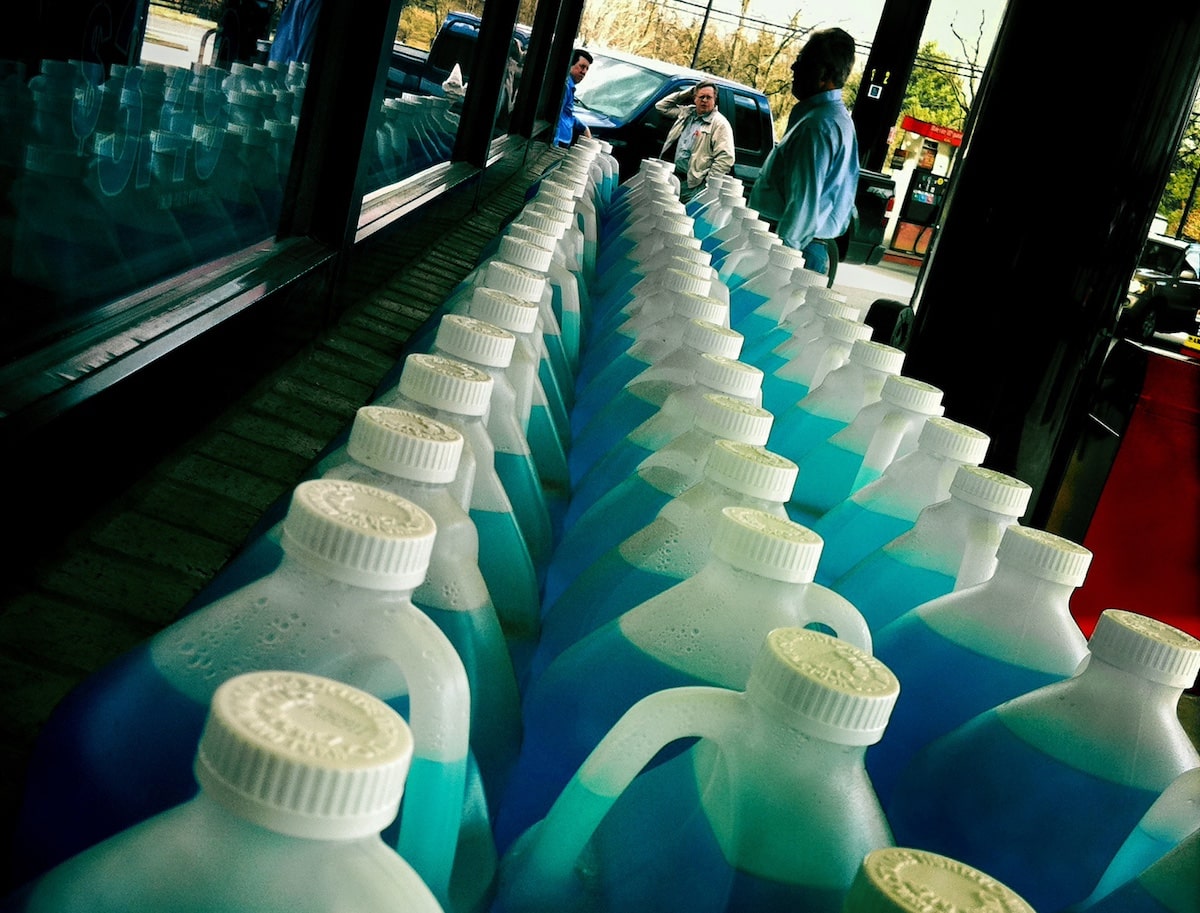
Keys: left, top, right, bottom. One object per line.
{"left": 493, "top": 626, "right": 898, "bottom": 913}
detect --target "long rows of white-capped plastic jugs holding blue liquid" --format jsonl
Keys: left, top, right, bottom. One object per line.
{"left": 4, "top": 142, "right": 1200, "bottom": 913}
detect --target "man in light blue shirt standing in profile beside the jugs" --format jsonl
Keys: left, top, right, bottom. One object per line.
{"left": 750, "top": 29, "right": 858, "bottom": 274}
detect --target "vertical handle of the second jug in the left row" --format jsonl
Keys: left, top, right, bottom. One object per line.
{"left": 392, "top": 607, "right": 470, "bottom": 906}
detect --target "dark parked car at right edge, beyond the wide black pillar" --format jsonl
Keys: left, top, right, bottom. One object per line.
{"left": 1117, "top": 235, "right": 1200, "bottom": 342}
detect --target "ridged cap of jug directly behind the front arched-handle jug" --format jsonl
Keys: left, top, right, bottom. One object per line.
{"left": 713, "top": 507, "right": 824, "bottom": 575}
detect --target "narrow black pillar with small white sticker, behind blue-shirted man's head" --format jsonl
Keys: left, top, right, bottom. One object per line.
{"left": 851, "top": 0, "right": 931, "bottom": 172}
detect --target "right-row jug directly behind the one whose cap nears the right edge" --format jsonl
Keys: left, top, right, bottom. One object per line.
{"left": 859, "top": 525, "right": 1092, "bottom": 800}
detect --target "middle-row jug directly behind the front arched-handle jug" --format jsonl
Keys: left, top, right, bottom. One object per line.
{"left": 496, "top": 507, "right": 871, "bottom": 851}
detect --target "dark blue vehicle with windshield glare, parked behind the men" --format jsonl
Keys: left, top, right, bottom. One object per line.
{"left": 575, "top": 50, "right": 775, "bottom": 188}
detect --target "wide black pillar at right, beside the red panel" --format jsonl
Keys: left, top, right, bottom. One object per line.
{"left": 905, "top": 0, "right": 1200, "bottom": 527}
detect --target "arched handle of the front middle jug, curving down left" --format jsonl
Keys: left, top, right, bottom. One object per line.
{"left": 505, "top": 685, "right": 746, "bottom": 908}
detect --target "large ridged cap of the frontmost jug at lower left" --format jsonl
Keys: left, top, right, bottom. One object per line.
{"left": 196, "top": 671, "right": 413, "bottom": 840}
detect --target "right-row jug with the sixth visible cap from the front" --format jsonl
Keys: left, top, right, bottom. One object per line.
{"left": 770, "top": 340, "right": 904, "bottom": 464}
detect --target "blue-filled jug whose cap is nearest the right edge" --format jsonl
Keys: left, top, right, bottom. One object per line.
{"left": 887, "top": 608, "right": 1200, "bottom": 913}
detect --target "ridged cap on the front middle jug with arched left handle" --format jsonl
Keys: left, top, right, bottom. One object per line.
{"left": 746, "top": 627, "right": 900, "bottom": 745}
